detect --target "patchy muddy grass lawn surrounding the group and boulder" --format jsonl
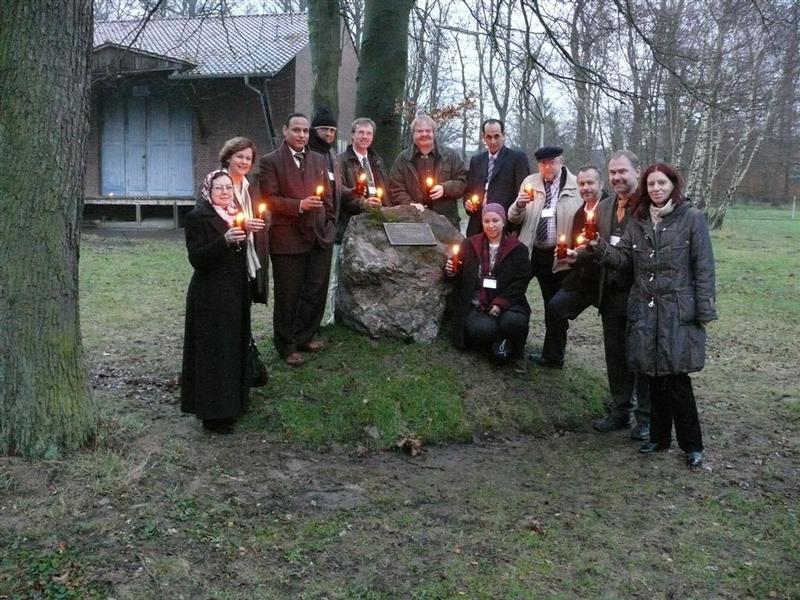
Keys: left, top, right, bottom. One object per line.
{"left": 0, "top": 209, "right": 800, "bottom": 600}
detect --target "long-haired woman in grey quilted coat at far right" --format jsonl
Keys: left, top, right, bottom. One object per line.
{"left": 572, "top": 163, "right": 717, "bottom": 467}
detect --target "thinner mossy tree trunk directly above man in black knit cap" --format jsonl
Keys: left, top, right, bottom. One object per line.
{"left": 308, "top": 0, "right": 342, "bottom": 117}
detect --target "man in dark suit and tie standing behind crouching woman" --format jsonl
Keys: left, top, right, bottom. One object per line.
{"left": 464, "top": 119, "right": 531, "bottom": 237}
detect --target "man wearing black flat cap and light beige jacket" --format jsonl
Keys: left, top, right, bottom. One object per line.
{"left": 508, "top": 146, "right": 581, "bottom": 368}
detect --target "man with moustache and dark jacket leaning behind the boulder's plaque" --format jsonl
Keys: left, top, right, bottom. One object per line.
{"left": 389, "top": 115, "right": 467, "bottom": 227}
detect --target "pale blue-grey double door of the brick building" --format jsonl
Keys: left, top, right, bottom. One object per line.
{"left": 100, "top": 93, "right": 193, "bottom": 197}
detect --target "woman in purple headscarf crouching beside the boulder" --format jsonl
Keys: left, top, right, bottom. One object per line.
{"left": 445, "top": 203, "right": 531, "bottom": 371}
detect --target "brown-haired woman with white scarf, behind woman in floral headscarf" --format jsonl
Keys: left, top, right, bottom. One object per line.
{"left": 219, "top": 136, "right": 269, "bottom": 304}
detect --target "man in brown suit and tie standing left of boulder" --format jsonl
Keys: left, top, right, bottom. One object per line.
{"left": 258, "top": 113, "right": 336, "bottom": 366}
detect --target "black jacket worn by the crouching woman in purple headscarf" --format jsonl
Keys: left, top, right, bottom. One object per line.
{"left": 452, "top": 233, "right": 531, "bottom": 350}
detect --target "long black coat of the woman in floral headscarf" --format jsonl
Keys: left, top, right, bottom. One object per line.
{"left": 181, "top": 202, "right": 250, "bottom": 420}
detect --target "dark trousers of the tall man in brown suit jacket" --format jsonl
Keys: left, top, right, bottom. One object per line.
{"left": 270, "top": 245, "right": 333, "bottom": 358}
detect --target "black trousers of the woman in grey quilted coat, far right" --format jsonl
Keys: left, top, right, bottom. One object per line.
{"left": 649, "top": 373, "right": 703, "bottom": 452}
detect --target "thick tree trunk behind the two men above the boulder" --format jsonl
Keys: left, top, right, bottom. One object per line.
{"left": 356, "top": 0, "right": 414, "bottom": 163}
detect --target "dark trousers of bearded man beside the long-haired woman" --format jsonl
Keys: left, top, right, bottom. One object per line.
{"left": 601, "top": 312, "right": 650, "bottom": 425}
